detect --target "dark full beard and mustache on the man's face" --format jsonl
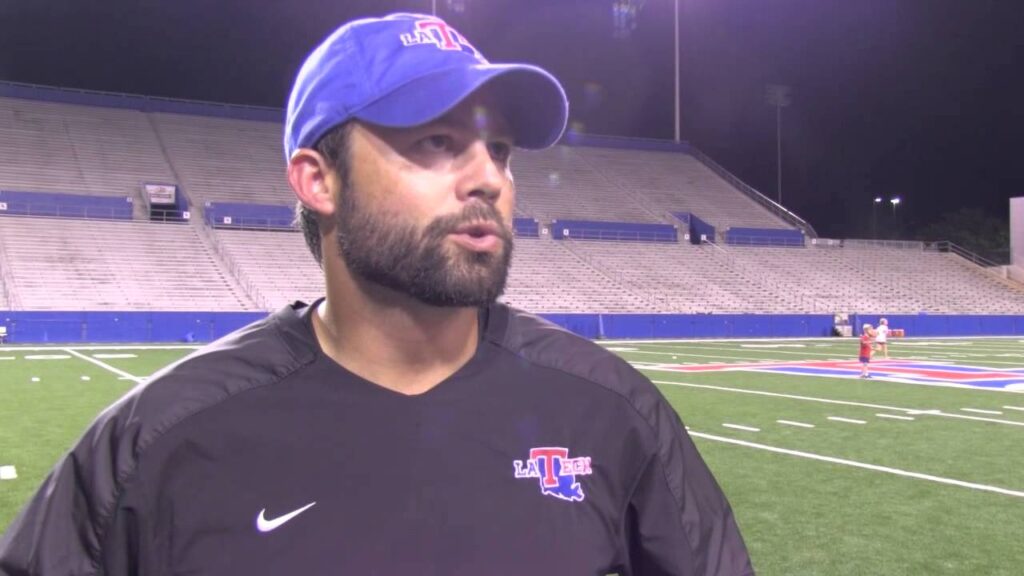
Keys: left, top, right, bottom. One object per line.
{"left": 337, "top": 186, "right": 512, "bottom": 307}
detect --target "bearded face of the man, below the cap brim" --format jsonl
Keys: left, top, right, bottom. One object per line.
{"left": 337, "top": 92, "right": 514, "bottom": 306}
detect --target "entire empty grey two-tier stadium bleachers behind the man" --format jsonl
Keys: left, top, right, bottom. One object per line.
{"left": 0, "top": 88, "right": 1024, "bottom": 314}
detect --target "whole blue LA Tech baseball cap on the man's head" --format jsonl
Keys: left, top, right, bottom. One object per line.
{"left": 285, "top": 13, "right": 568, "bottom": 161}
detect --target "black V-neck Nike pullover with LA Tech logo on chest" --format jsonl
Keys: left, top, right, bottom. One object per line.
{"left": 0, "top": 303, "right": 753, "bottom": 576}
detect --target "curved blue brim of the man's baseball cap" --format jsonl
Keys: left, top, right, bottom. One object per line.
{"left": 352, "top": 64, "right": 568, "bottom": 150}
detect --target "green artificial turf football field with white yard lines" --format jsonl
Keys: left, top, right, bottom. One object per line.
{"left": 0, "top": 337, "right": 1024, "bottom": 576}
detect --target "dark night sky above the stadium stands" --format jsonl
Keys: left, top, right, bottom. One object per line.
{"left": 0, "top": 0, "right": 1024, "bottom": 237}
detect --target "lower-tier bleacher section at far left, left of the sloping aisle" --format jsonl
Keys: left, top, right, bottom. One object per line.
{"left": 0, "top": 216, "right": 256, "bottom": 311}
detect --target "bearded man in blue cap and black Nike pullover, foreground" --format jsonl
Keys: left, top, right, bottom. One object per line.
{"left": 0, "top": 14, "right": 753, "bottom": 576}
